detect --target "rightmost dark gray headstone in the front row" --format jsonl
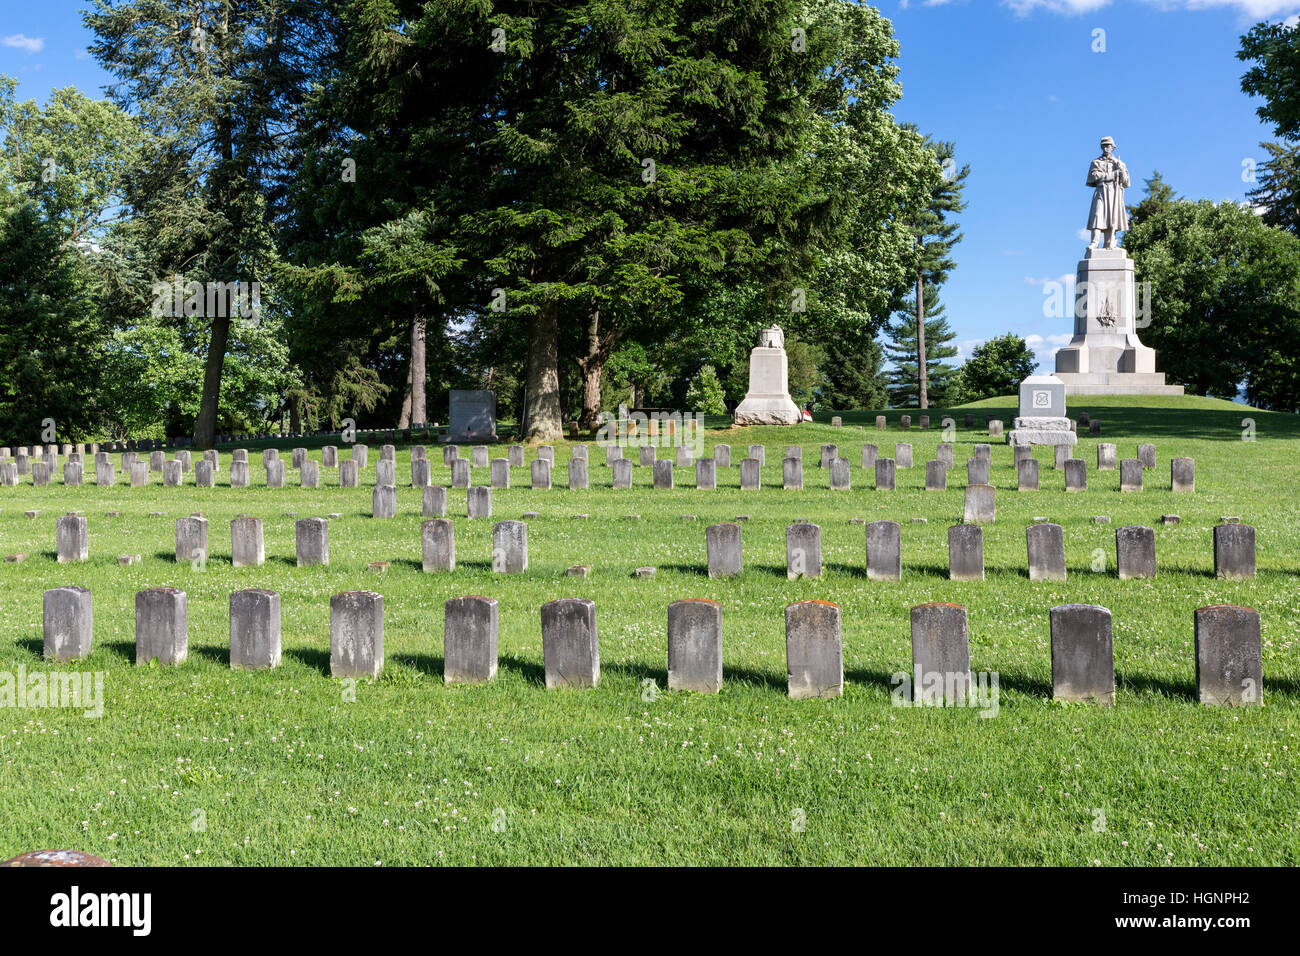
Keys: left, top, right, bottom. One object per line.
{"left": 1192, "top": 604, "right": 1264, "bottom": 706}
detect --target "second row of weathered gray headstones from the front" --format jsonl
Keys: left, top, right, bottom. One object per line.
{"left": 43, "top": 512, "right": 1256, "bottom": 581}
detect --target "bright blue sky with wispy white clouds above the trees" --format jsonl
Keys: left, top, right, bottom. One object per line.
{"left": 0, "top": 0, "right": 1300, "bottom": 368}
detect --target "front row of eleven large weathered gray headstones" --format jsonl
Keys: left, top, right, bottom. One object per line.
{"left": 43, "top": 585, "right": 1264, "bottom": 706}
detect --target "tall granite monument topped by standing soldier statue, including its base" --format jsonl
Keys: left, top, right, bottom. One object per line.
{"left": 1056, "top": 137, "right": 1183, "bottom": 395}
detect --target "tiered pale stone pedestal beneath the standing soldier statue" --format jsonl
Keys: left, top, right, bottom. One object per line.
{"left": 1056, "top": 248, "right": 1183, "bottom": 395}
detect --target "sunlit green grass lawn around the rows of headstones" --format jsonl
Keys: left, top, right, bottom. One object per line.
{"left": 0, "top": 397, "right": 1300, "bottom": 866}
